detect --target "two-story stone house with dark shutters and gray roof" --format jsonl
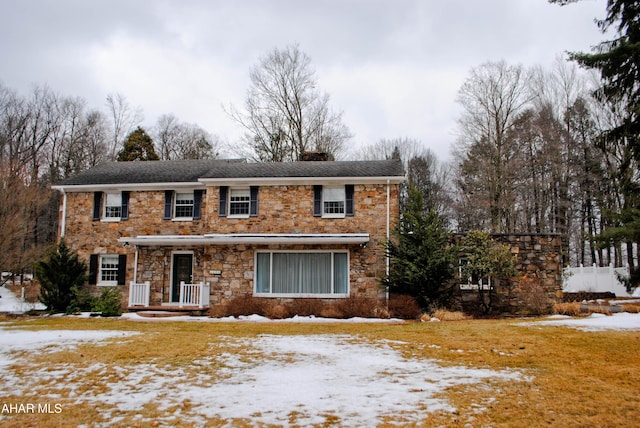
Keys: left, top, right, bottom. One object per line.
{"left": 55, "top": 160, "right": 404, "bottom": 308}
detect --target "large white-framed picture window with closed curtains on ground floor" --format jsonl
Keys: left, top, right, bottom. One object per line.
{"left": 254, "top": 251, "right": 349, "bottom": 297}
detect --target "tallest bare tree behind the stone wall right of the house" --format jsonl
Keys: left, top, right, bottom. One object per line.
{"left": 455, "top": 61, "right": 533, "bottom": 233}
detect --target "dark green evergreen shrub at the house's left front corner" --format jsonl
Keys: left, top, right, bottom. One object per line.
{"left": 35, "top": 241, "right": 87, "bottom": 312}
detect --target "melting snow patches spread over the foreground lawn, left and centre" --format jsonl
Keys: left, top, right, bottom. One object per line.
{"left": 0, "top": 325, "right": 530, "bottom": 426}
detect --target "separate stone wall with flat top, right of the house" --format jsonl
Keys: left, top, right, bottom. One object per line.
{"left": 458, "top": 234, "right": 566, "bottom": 315}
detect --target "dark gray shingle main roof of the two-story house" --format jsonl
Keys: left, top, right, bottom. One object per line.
{"left": 60, "top": 160, "right": 404, "bottom": 186}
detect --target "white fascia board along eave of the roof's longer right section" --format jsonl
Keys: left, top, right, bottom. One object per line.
{"left": 198, "top": 176, "right": 405, "bottom": 186}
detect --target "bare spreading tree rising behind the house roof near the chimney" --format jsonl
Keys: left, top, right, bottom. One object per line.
{"left": 227, "top": 46, "right": 351, "bottom": 162}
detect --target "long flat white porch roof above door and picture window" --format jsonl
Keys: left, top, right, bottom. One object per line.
{"left": 118, "top": 233, "right": 369, "bottom": 246}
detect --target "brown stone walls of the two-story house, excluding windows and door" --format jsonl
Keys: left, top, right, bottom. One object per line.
{"left": 61, "top": 183, "right": 399, "bottom": 306}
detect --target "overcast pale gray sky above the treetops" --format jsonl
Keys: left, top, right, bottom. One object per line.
{"left": 0, "top": 0, "right": 606, "bottom": 160}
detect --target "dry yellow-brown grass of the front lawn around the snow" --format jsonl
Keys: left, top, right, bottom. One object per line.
{"left": 0, "top": 318, "right": 640, "bottom": 427}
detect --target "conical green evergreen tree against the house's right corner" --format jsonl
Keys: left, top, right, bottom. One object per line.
{"left": 384, "top": 184, "right": 457, "bottom": 310}
